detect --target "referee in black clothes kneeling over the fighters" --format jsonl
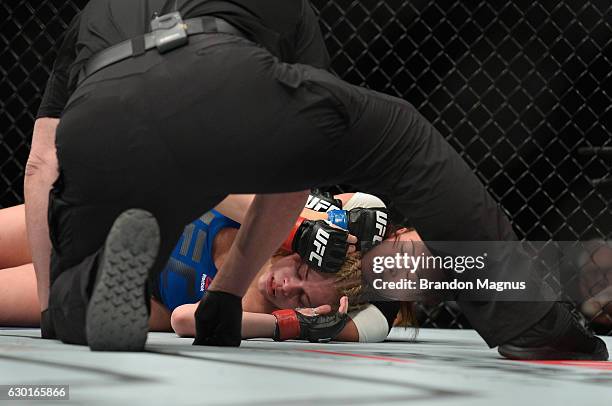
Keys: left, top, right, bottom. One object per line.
{"left": 25, "top": 0, "right": 608, "bottom": 359}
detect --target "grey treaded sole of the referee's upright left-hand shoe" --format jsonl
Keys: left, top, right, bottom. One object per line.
{"left": 86, "top": 209, "right": 160, "bottom": 351}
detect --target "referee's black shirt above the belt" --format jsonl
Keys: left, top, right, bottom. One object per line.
{"left": 37, "top": 0, "right": 329, "bottom": 118}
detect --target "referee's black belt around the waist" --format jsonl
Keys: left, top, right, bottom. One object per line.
{"left": 79, "top": 16, "right": 246, "bottom": 83}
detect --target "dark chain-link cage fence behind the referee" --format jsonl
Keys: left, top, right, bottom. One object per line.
{"left": 0, "top": 0, "right": 612, "bottom": 333}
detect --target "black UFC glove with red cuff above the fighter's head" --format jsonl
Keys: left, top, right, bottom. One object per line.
{"left": 282, "top": 217, "right": 348, "bottom": 273}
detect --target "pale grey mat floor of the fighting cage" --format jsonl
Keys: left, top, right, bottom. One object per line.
{"left": 0, "top": 329, "right": 612, "bottom": 406}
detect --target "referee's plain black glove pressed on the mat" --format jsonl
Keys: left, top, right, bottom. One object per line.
{"left": 193, "top": 290, "right": 242, "bottom": 347}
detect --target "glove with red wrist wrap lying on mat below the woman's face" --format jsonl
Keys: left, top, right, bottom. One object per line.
{"left": 272, "top": 309, "right": 348, "bottom": 343}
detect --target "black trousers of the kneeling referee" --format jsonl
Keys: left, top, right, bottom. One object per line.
{"left": 49, "top": 34, "right": 551, "bottom": 346}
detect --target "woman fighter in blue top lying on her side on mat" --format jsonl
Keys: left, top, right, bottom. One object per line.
{"left": 0, "top": 193, "right": 409, "bottom": 342}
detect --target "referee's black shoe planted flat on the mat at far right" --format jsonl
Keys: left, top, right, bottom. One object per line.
{"left": 497, "top": 303, "right": 608, "bottom": 361}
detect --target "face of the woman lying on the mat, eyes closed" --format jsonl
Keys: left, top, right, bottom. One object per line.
{"left": 257, "top": 254, "right": 338, "bottom": 309}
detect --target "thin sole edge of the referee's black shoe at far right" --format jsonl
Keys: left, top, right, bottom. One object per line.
{"left": 497, "top": 344, "right": 608, "bottom": 361}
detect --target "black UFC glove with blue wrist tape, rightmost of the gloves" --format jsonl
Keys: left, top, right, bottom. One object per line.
{"left": 328, "top": 207, "right": 389, "bottom": 252}
